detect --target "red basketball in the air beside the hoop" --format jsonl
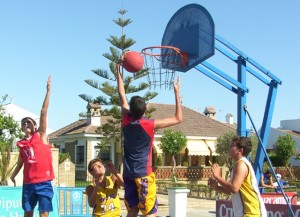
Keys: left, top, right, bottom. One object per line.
{"left": 123, "top": 51, "right": 144, "bottom": 72}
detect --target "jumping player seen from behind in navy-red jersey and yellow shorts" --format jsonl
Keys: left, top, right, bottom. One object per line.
{"left": 116, "top": 56, "right": 183, "bottom": 217}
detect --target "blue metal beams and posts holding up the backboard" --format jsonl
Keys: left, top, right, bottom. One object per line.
{"left": 195, "top": 35, "right": 294, "bottom": 216}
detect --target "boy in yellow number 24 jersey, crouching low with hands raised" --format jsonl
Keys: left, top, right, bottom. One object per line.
{"left": 85, "top": 158, "right": 124, "bottom": 217}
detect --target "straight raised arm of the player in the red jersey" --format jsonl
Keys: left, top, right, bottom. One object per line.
{"left": 39, "top": 76, "right": 51, "bottom": 144}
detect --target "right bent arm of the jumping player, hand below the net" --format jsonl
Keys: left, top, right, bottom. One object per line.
{"left": 154, "top": 76, "right": 183, "bottom": 129}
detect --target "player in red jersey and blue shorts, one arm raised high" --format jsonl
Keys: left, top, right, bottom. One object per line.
{"left": 11, "top": 76, "right": 54, "bottom": 217}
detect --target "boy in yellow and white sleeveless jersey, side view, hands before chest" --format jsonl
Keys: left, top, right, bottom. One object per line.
{"left": 208, "top": 136, "right": 267, "bottom": 217}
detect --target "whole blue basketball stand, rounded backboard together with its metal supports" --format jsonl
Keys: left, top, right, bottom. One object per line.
{"left": 159, "top": 4, "right": 295, "bottom": 216}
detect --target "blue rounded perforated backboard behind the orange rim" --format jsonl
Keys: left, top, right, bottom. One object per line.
{"left": 161, "top": 4, "right": 215, "bottom": 72}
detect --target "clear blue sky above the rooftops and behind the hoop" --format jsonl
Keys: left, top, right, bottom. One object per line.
{"left": 0, "top": 0, "right": 300, "bottom": 130}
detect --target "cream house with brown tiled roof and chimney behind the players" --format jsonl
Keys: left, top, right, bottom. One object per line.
{"left": 49, "top": 103, "right": 236, "bottom": 181}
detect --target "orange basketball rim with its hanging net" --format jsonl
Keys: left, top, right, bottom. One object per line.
{"left": 141, "top": 46, "right": 188, "bottom": 89}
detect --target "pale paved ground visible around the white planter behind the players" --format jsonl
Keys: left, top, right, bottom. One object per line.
{"left": 119, "top": 190, "right": 216, "bottom": 217}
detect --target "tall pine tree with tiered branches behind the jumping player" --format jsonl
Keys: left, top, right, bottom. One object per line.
{"left": 79, "top": 9, "right": 157, "bottom": 147}
